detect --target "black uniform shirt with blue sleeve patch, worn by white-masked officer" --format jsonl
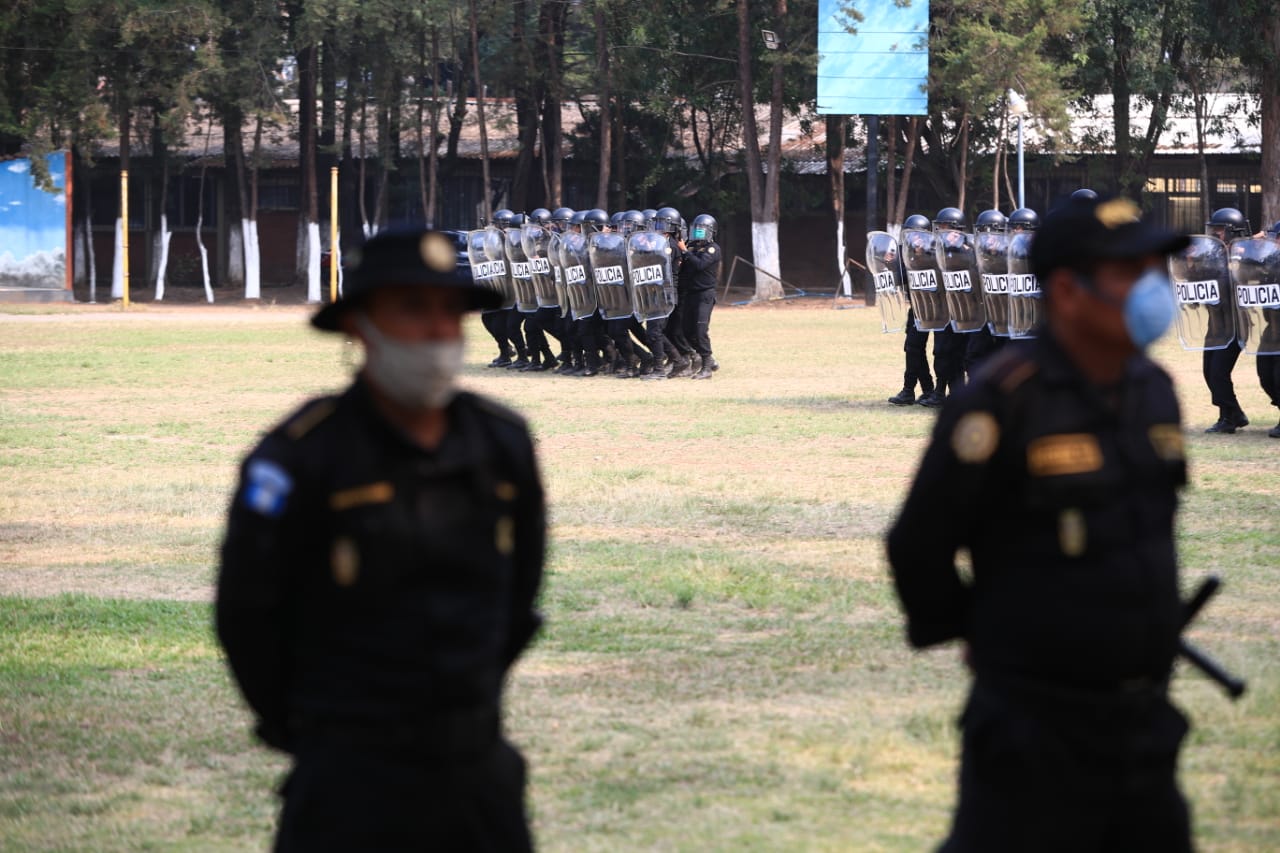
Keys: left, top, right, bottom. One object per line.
{"left": 216, "top": 379, "right": 545, "bottom": 748}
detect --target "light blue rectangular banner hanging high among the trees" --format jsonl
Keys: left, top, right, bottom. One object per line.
{"left": 818, "top": 0, "right": 929, "bottom": 115}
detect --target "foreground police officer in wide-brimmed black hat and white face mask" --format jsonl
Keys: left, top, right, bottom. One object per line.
{"left": 216, "top": 222, "right": 545, "bottom": 850}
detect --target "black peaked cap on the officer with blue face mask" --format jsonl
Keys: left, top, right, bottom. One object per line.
{"left": 1032, "top": 199, "right": 1190, "bottom": 281}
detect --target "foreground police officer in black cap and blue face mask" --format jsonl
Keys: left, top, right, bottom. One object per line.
{"left": 888, "top": 199, "right": 1190, "bottom": 853}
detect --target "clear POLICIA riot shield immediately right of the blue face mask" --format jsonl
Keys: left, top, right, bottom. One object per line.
{"left": 1169, "top": 234, "right": 1235, "bottom": 351}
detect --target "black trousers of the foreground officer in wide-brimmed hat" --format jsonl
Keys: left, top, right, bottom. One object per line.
{"left": 275, "top": 740, "right": 532, "bottom": 853}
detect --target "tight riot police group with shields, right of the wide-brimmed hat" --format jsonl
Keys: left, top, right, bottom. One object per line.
{"left": 467, "top": 207, "right": 721, "bottom": 379}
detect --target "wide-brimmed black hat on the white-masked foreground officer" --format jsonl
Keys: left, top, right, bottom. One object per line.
{"left": 311, "top": 225, "right": 502, "bottom": 332}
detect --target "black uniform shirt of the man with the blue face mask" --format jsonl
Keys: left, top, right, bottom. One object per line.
{"left": 888, "top": 337, "right": 1185, "bottom": 688}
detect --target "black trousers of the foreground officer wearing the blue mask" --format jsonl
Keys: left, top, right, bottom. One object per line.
{"left": 940, "top": 684, "right": 1192, "bottom": 853}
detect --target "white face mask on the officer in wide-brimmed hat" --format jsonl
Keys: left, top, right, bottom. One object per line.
{"left": 356, "top": 314, "right": 463, "bottom": 411}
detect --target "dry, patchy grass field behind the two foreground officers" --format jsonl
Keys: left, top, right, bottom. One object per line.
{"left": 0, "top": 302, "right": 1280, "bottom": 850}
